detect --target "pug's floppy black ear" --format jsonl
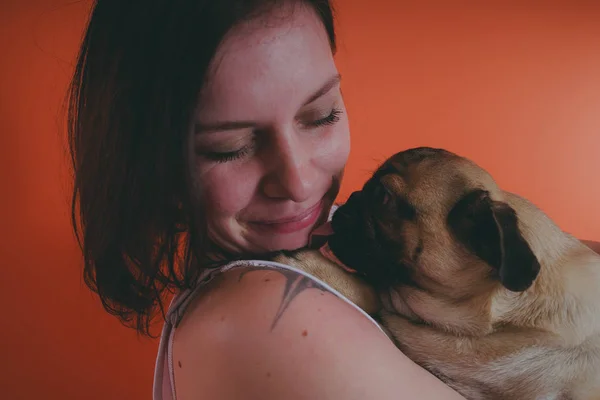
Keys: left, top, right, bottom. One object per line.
{"left": 448, "top": 190, "right": 540, "bottom": 292}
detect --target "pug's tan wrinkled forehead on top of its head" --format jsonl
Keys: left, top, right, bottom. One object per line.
{"left": 374, "top": 150, "right": 499, "bottom": 212}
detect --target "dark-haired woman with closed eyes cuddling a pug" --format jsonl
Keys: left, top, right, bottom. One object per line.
{"left": 70, "top": 0, "right": 596, "bottom": 400}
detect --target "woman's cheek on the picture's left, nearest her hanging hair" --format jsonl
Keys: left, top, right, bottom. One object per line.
{"left": 195, "top": 164, "right": 259, "bottom": 219}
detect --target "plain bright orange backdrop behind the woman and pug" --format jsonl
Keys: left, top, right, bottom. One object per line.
{"left": 0, "top": 0, "right": 600, "bottom": 400}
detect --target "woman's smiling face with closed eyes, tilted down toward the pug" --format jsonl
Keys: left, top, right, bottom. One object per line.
{"left": 190, "top": 6, "right": 350, "bottom": 253}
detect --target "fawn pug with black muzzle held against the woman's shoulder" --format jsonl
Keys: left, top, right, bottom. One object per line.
{"left": 278, "top": 147, "right": 600, "bottom": 400}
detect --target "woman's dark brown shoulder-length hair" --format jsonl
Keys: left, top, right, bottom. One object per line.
{"left": 68, "top": 0, "right": 335, "bottom": 335}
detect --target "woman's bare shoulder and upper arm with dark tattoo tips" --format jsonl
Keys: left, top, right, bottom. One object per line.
{"left": 173, "top": 269, "right": 461, "bottom": 400}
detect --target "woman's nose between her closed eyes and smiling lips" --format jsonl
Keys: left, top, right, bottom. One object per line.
{"left": 263, "top": 129, "right": 319, "bottom": 203}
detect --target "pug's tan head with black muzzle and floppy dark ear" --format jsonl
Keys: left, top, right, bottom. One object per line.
{"left": 329, "top": 148, "right": 540, "bottom": 298}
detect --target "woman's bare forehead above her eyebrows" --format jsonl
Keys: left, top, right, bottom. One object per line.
{"left": 199, "top": 3, "right": 337, "bottom": 120}
